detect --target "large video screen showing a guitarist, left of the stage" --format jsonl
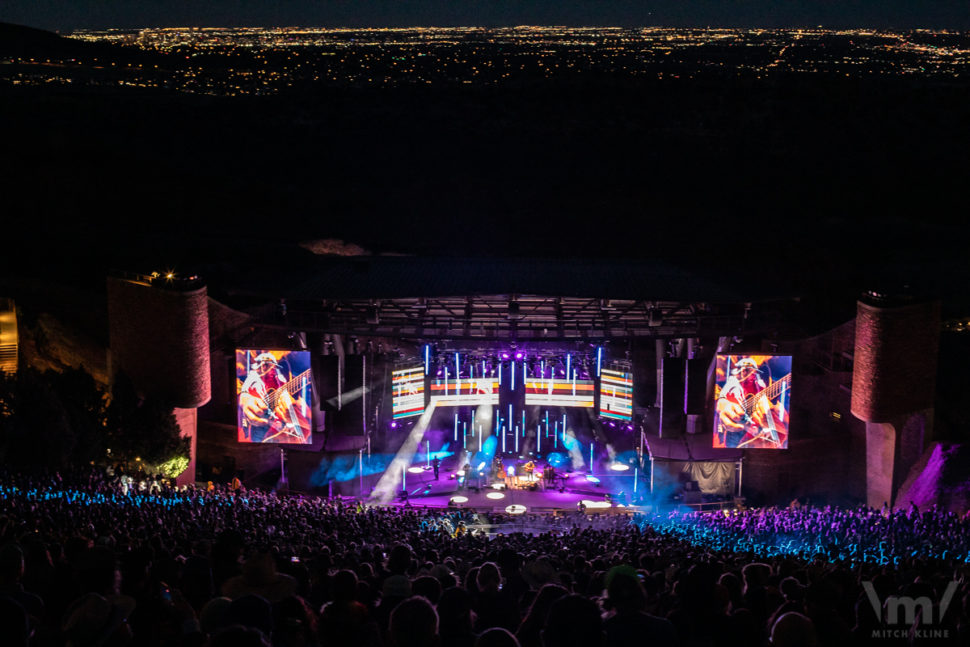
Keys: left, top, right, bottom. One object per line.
{"left": 236, "top": 349, "right": 313, "bottom": 445}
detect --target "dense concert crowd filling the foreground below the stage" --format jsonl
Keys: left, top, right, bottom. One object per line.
{"left": 0, "top": 466, "right": 970, "bottom": 647}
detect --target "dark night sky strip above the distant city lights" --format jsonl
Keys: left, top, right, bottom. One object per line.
{"left": 0, "top": 0, "right": 970, "bottom": 30}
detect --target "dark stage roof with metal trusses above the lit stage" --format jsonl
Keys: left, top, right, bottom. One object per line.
{"left": 221, "top": 256, "right": 786, "bottom": 341}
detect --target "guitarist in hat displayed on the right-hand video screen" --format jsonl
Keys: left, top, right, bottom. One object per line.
{"left": 717, "top": 357, "right": 791, "bottom": 448}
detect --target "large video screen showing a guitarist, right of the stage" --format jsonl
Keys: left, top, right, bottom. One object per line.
{"left": 714, "top": 355, "right": 792, "bottom": 449}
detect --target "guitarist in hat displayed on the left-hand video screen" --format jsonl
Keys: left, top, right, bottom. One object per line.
{"left": 239, "top": 353, "right": 309, "bottom": 443}
